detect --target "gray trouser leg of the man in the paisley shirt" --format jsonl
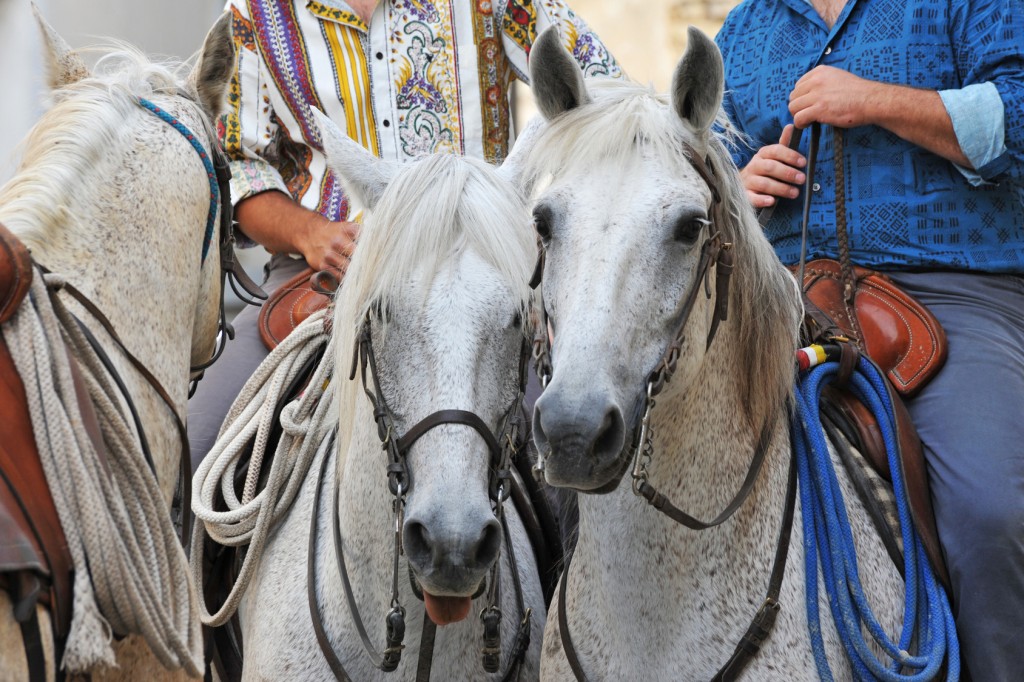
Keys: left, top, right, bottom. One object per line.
{"left": 188, "top": 255, "right": 306, "bottom": 471}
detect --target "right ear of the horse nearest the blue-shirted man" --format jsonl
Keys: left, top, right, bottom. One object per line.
{"left": 672, "top": 26, "right": 725, "bottom": 134}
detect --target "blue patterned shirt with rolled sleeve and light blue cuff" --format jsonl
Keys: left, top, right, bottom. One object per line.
{"left": 716, "top": 0, "right": 1024, "bottom": 272}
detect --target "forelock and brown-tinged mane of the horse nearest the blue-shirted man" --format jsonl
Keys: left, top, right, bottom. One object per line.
{"left": 523, "top": 79, "right": 801, "bottom": 428}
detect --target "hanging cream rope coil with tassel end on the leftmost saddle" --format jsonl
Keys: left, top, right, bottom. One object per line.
{"left": 0, "top": 272, "right": 203, "bottom": 676}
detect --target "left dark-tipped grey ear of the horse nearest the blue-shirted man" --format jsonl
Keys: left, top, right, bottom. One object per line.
{"left": 529, "top": 26, "right": 590, "bottom": 121}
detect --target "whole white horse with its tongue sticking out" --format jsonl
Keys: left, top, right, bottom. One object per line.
{"left": 228, "top": 109, "right": 545, "bottom": 681}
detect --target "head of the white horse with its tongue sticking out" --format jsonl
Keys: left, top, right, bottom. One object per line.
{"left": 317, "top": 113, "right": 536, "bottom": 624}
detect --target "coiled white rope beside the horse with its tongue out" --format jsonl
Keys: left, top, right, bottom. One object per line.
{"left": 190, "top": 310, "right": 337, "bottom": 627}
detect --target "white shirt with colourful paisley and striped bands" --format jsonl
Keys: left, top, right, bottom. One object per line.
{"left": 219, "top": 0, "right": 621, "bottom": 229}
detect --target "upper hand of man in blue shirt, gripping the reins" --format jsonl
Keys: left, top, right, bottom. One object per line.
{"left": 790, "top": 67, "right": 887, "bottom": 128}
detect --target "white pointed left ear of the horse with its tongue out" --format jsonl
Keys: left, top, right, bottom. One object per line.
{"left": 310, "top": 108, "right": 398, "bottom": 209}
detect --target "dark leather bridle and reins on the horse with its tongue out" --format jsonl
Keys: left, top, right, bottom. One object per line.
{"left": 306, "top": 313, "right": 532, "bottom": 682}
